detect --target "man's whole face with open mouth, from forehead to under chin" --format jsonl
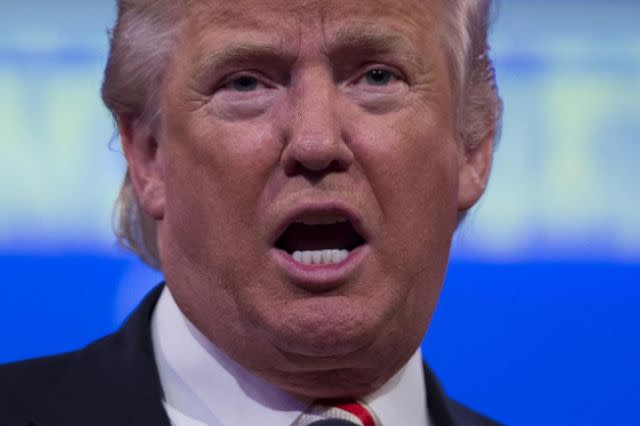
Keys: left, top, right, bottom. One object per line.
{"left": 144, "top": 0, "right": 484, "bottom": 397}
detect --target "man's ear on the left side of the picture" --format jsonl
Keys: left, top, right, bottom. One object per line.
{"left": 118, "top": 114, "right": 165, "bottom": 220}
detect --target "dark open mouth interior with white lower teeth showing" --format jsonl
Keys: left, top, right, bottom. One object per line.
{"left": 275, "top": 213, "right": 366, "bottom": 265}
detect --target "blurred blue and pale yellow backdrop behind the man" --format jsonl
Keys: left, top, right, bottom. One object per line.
{"left": 0, "top": 0, "right": 640, "bottom": 425}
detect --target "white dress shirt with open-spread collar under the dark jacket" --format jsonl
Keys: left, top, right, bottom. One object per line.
{"left": 151, "top": 286, "right": 430, "bottom": 426}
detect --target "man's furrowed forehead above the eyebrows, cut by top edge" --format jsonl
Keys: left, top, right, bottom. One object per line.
{"left": 180, "top": 0, "right": 439, "bottom": 47}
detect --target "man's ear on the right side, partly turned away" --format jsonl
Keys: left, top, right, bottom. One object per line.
{"left": 458, "top": 131, "right": 495, "bottom": 214}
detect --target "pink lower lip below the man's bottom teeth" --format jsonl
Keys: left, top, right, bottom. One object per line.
{"left": 272, "top": 244, "right": 369, "bottom": 292}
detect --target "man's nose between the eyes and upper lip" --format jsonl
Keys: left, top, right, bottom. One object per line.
{"left": 281, "top": 72, "right": 353, "bottom": 178}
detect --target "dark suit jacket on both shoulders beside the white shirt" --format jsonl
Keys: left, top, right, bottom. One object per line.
{"left": 0, "top": 286, "right": 496, "bottom": 426}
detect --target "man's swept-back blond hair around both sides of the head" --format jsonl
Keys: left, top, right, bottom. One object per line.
{"left": 102, "top": 0, "right": 502, "bottom": 269}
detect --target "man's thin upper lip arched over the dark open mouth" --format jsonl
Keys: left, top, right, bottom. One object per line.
{"left": 271, "top": 201, "right": 369, "bottom": 245}
